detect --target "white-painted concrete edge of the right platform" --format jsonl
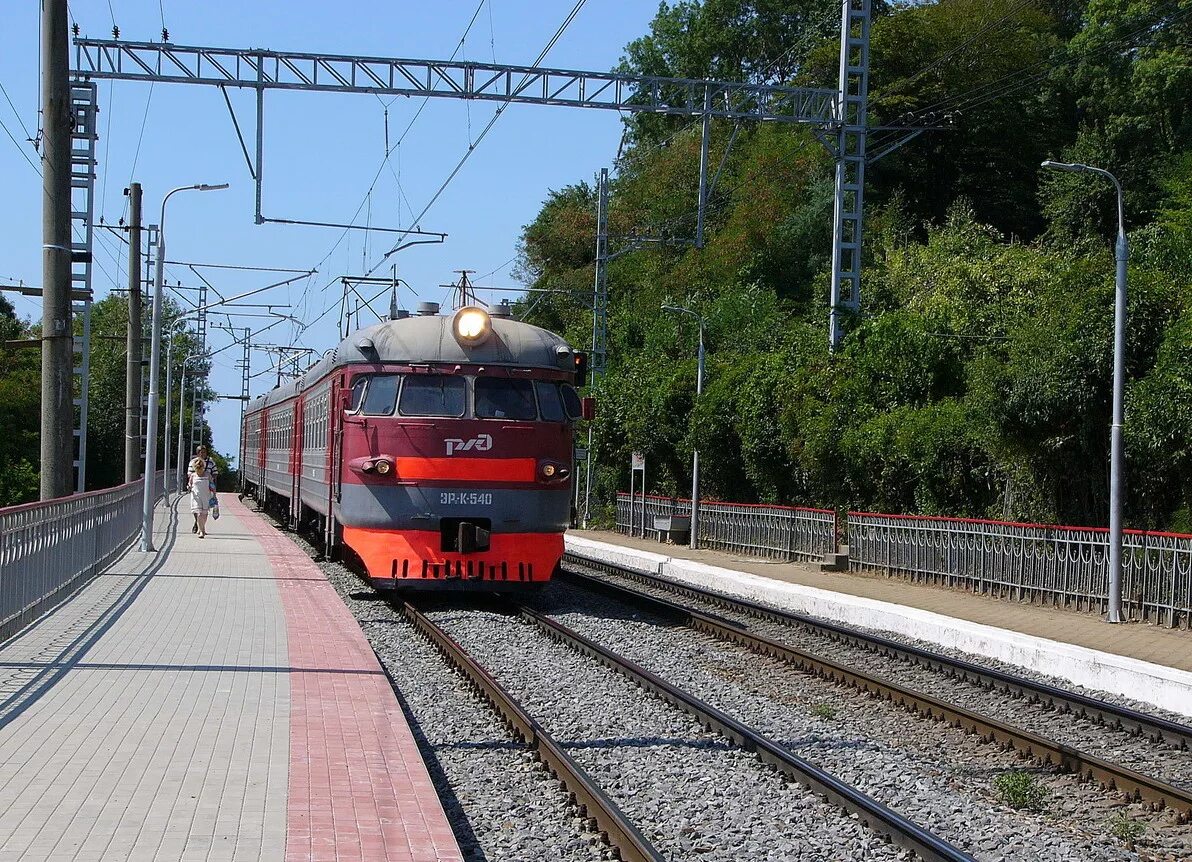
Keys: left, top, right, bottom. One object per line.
{"left": 566, "top": 534, "right": 1192, "bottom": 717}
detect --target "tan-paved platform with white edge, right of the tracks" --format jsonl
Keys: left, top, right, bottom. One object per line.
{"left": 567, "top": 531, "right": 1192, "bottom": 717}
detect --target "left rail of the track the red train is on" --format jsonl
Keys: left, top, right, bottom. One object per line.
{"left": 399, "top": 602, "right": 664, "bottom": 862}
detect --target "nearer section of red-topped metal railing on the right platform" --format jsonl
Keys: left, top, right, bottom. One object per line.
{"left": 849, "top": 511, "right": 1192, "bottom": 627}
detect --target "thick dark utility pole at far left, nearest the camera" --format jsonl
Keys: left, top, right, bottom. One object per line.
{"left": 42, "top": 0, "right": 74, "bottom": 500}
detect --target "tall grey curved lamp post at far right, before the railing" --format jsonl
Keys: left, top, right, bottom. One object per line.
{"left": 1043, "top": 160, "right": 1130, "bottom": 622}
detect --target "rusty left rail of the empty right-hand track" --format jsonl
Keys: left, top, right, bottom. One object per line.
{"left": 565, "top": 572, "right": 1192, "bottom": 819}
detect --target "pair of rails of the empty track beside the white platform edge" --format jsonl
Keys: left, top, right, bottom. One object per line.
{"left": 563, "top": 554, "right": 1192, "bottom": 820}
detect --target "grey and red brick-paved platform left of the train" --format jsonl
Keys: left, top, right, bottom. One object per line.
{"left": 0, "top": 495, "right": 461, "bottom": 862}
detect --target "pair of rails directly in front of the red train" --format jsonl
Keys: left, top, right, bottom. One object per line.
{"left": 401, "top": 602, "right": 973, "bottom": 862}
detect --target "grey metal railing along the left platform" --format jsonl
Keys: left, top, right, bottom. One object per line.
{"left": 0, "top": 473, "right": 164, "bottom": 639}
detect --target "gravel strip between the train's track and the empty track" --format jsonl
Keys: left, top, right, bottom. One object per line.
{"left": 540, "top": 584, "right": 1192, "bottom": 860}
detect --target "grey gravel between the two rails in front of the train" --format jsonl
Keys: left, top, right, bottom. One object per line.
{"left": 429, "top": 600, "right": 905, "bottom": 862}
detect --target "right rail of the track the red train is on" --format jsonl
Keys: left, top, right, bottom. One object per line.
{"left": 519, "top": 606, "right": 973, "bottom": 862}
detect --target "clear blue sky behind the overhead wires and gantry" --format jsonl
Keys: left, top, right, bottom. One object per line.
{"left": 0, "top": 0, "right": 657, "bottom": 464}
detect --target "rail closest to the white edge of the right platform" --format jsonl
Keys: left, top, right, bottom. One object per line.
{"left": 564, "top": 553, "right": 1192, "bottom": 750}
